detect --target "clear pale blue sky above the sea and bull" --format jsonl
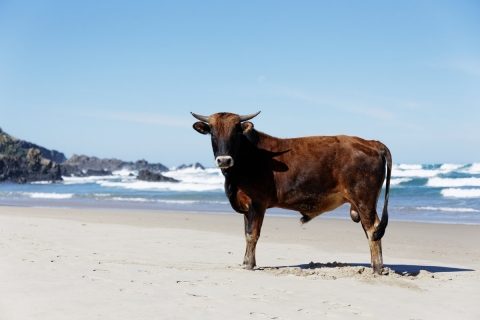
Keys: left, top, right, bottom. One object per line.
{"left": 0, "top": 0, "right": 480, "bottom": 166}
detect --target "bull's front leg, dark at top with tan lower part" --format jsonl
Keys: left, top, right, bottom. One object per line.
{"left": 243, "top": 202, "right": 266, "bottom": 270}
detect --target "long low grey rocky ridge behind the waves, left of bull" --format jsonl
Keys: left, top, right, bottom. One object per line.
{"left": 62, "top": 154, "right": 168, "bottom": 172}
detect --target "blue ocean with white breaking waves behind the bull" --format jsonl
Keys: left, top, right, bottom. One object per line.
{"left": 0, "top": 163, "right": 480, "bottom": 225}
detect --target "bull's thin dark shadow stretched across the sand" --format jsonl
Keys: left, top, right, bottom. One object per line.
{"left": 268, "top": 262, "right": 476, "bottom": 274}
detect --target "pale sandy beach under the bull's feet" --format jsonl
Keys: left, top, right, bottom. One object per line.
{"left": 0, "top": 207, "right": 480, "bottom": 320}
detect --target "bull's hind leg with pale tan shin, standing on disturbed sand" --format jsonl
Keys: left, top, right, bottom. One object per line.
{"left": 359, "top": 206, "right": 383, "bottom": 274}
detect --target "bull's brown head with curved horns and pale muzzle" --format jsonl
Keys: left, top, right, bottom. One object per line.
{"left": 191, "top": 111, "right": 260, "bottom": 169}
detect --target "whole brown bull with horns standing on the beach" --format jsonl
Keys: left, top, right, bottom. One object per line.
{"left": 192, "top": 112, "right": 392, "bottom": 273}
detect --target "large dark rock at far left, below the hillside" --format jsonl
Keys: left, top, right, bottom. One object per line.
{"left": 0, "top": 148, "right": 62, "bottom": 183}
